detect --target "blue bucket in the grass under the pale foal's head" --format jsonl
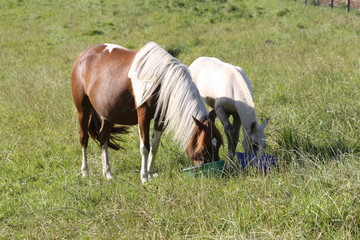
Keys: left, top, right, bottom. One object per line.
{"left": 236, "top": 152, "right": 276, "bottom": 172}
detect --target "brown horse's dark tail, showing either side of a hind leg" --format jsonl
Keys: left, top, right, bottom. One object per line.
{"left": 88, "top": 110, "right": 128, "bottom": 150}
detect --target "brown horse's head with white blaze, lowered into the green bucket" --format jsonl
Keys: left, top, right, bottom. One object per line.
{"left": 186, "top": 110, "right": 223, "bottom": 165}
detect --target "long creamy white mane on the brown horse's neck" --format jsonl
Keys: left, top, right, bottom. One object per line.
{"left": 129, "top": 42, "right": 207, "bottom": 148}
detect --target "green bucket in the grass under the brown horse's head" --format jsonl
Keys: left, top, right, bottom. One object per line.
{"left": 183, "top": 160, "right": 225, "bottom": 177}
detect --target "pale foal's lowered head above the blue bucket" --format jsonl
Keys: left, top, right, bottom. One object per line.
{"left": 242, "top": 118, "right": 269, "bottom": 156}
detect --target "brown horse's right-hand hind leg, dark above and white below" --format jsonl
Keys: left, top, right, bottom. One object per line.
{"left": 99, "top": 119, "right": 114, "bottom": 180}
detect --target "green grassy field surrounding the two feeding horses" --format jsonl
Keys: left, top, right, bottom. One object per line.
{"left": 0, "top": 0, "right": 360, "bottom": 239}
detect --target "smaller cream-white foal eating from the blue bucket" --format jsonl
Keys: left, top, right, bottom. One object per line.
{"left": 189, "top": 57, "right": 268, "bottom": 160}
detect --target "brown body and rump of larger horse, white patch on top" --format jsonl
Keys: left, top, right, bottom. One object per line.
{"left": 72, "top": 44, "right": 136, "bottom": 123}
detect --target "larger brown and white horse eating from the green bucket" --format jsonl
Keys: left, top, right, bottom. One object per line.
{"left": 71, "top": 42, "right": 223, "bottom": 183}
